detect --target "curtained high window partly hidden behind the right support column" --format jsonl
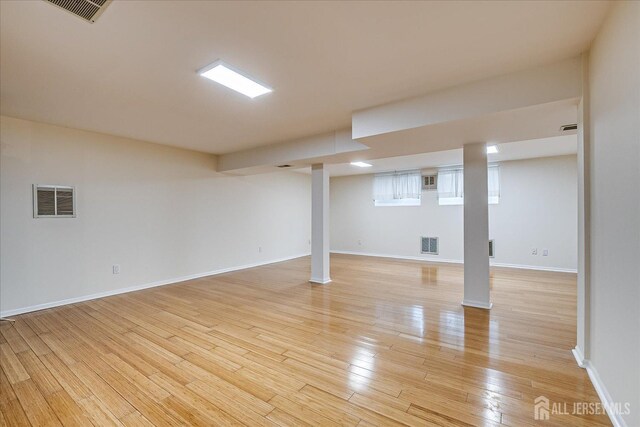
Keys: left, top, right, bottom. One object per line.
{"left": 438, "top": 166, "right": 500, "bottom": 206}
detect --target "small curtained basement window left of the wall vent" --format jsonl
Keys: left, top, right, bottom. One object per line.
{"left": 373, "top": 171, "right": 422, "bottom": 206}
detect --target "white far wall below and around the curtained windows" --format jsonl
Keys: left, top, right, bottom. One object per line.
{"left": 331, "top": 155, "right": 577, "bottom": 271}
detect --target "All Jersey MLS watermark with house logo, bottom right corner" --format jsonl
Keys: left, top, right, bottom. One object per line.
{"left": 533, "top": 396, "right": 631, "bottom": 421}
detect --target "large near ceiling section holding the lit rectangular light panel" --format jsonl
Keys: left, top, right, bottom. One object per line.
{"left": 0, "top": 0, "right": 609, "bottom": 154}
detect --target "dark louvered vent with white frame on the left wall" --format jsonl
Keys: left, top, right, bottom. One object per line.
{"left": 33, "top": 184, "right": 76, "bottom": 218}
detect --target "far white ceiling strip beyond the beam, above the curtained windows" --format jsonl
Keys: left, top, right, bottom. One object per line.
{"left": 310, "top": 133, "right": 578, "bottom": 176}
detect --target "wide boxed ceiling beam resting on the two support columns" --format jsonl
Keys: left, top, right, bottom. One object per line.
{"left": 217, "top": 57, "right": 582, "bottom": 174}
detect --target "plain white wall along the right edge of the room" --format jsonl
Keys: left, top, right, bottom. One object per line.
{"left": 588, "top": 2, "right": 640, "bottom": 426}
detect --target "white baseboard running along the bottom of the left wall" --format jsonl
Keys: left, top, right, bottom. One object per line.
{"left": 0, "top": 253, "right": 310, "bottom": 317}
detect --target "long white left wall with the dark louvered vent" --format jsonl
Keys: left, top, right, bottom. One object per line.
{"left": 0, "top": 117, "right": 311, "bottom": 314}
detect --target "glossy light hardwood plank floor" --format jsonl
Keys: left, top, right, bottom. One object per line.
{"left": 0, "top": 255, "right": 610, "bottom": 426}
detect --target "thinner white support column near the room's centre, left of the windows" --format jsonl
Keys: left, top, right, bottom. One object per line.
{"left": 309, "top": 164, "right": 331, "bottom": 284}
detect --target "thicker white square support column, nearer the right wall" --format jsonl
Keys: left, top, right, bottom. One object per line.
{"left": 462, "top": 143, "right": 492, "bottom": 309}
